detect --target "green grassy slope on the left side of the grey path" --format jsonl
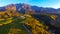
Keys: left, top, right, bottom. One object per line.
{"left": 0, "top": 17, "right": 28, "bottom": 34}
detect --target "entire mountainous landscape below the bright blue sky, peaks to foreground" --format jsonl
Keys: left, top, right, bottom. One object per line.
{"left": 0, "top": 4, "right": 60, "bottom": 34}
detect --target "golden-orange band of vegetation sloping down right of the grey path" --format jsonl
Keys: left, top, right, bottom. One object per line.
{"left": 24, "top": 15, "right": 50, "bottom": 34}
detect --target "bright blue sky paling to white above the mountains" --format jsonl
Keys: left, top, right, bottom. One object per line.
{"left": 0, "top": 0, "right": 60, "bottom": 8}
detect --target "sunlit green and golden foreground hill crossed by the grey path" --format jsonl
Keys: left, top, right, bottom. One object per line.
{"left": 0, "top": 11, "right": 50, "bottom": 34}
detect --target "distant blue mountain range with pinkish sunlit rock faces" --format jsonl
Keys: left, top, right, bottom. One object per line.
{"left": 0, "top": 3, "right": 60, "bottom": 13}
